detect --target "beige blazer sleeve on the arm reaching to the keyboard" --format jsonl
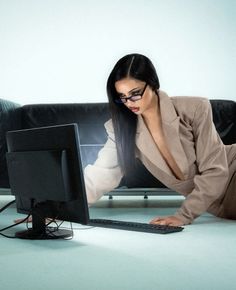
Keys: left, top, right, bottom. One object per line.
{"left": 175, "top": 99, "right": 229, "bottom": 224}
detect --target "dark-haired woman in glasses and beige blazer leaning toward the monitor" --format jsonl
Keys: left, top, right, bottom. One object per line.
{"left": 85, "top": 54, "right": 236, "bottom": 226}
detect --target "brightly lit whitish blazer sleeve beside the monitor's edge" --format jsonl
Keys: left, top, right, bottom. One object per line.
{"left": 84, "top": 120, "right": 122, "bottom": 205}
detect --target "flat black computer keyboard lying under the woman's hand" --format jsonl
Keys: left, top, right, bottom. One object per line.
{"left": 89, "top": 219, "right": 184, "bottom": 234}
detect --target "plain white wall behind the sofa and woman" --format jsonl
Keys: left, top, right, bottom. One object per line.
{"left": 0, "top": 0, "right": 236, "bottom": 104}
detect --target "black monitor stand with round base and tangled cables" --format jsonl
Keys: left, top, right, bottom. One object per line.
{"left": 15, "top": 202, "right": 73, "bottom": 240}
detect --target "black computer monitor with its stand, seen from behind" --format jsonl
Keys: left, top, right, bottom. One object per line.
{"left": 6, "top": 124, "right": 89, "bottom": 239}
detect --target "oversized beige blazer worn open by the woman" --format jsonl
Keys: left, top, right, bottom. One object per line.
{"left": 84, "top": 91, "right": 236, "bottom": 224}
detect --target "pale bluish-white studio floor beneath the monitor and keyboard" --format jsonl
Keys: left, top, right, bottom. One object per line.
{"left": 0, "top": 196, "right": 236, "bottom": 290}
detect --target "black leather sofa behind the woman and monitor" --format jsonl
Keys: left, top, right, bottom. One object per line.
{"left": 0, "top": 99, "right": 236, "bottom": 195}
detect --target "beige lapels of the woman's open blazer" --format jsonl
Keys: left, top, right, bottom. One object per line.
{"left": 136, "top": 91, "right": 188, "bottom": 178}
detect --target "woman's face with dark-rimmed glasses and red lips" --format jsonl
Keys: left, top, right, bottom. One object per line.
{"left": 115, "top": 78, "right": 157, "bottom": 115}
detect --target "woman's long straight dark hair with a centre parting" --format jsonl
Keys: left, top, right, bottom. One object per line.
{"left": 107, "top": 53, "right": 160, "bottom": 175}
